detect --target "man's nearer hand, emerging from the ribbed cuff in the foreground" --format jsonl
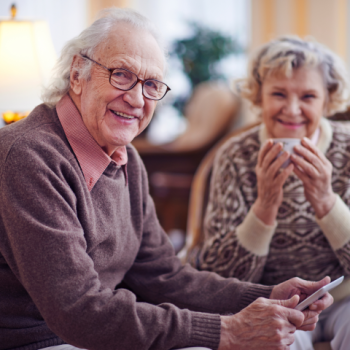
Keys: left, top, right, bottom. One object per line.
{"left": 218, "top": 296, "right": 304, "bottom": 350}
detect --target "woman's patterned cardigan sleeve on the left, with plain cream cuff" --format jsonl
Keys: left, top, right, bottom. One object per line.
{"left": 198, "top": 144, "right": 276, "bottom": 283}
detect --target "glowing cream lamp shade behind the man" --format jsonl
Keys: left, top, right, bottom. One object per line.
{"left": 0, "top": 20, "right": 56, "bottom": 112}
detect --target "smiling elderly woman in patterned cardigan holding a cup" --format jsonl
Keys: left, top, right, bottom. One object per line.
{"left": 194, "top": 37, "right": 350, "bottom": 350}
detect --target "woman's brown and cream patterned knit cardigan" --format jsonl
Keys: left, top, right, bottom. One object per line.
{"left": 191, "top": 118, "right": 350, "bottom": 294}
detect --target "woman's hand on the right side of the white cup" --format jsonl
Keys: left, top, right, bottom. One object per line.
{"left": 291, "top": 138, "right": 336, "bottom": 219}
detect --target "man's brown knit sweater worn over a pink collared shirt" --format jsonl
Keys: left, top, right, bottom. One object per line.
{"left": 0, "top": 105, "right": 272, "bottom": 350}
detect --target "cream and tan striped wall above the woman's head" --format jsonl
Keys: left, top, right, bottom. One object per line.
{"left": 250, "top": 0, "right": 350, "bottom": 66}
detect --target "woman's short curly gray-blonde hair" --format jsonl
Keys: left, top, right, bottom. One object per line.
{"left": 237, "top": 36, "right": 350, "bottom": 116}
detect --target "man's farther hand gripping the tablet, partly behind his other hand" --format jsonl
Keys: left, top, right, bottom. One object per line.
{"left": 270, "top": 276, "right": 333, "bottom": 331}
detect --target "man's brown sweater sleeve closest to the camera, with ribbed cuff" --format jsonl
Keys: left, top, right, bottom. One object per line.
{"left": 0, "top": 137, "right": 220, "bottom": 350}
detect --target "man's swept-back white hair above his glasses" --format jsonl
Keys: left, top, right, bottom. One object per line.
{"left": 41, "top": 7, "right": 165, "bottom": 107}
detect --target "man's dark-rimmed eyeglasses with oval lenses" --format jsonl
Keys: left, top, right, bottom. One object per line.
{"left": 81, "top": 55, "right": 171, "bottom": 101}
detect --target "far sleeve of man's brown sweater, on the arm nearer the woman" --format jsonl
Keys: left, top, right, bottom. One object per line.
{"left": 124, "top": 157, "right": 272, "bottom": 317}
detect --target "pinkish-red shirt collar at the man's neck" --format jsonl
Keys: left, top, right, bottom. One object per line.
{"left": 56, "top": 94, "right": 128, "bottom": 191}
